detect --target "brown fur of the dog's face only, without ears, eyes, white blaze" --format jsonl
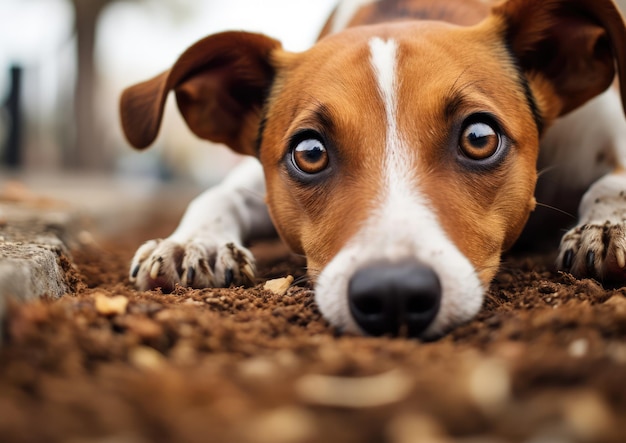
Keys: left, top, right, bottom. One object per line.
{"left": 261, "top": 23, "right": 538, "bottom": 282}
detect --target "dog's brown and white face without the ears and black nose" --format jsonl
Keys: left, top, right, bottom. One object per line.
{"left": 260, "top": 22, "right": 538, "bottom": 332}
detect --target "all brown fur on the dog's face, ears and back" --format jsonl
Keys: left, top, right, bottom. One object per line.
{"left": 121, "top": 0, "right": 626, "bottom": 283}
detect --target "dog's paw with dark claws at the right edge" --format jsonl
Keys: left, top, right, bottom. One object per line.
{"left": 557, "top": 221, "right": 626, "bottom": 281}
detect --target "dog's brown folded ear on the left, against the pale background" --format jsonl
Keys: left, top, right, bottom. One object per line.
{"left": 120, "top": 32, "right": 281, "bottom": 155}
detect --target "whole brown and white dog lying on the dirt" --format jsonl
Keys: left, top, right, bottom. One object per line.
{"left": 121, "top": 0, "right": 626, "bottom": 337}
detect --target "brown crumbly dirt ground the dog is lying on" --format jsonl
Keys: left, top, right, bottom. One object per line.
{"left": 0, "top": 206, "right": 626, "bottom": 443}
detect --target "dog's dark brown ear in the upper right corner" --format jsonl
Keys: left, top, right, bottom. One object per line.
{"left": 492, "top": 0, "right": 626, "bottom": 119}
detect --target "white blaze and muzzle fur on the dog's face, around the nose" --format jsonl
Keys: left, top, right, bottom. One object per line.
{"left": 316, "top": 38, "right": 484, "bottom": 337}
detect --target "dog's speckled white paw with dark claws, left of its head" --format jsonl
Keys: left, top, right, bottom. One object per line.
{"left": 130, "top": 239, "right": 256, "bottom": 292}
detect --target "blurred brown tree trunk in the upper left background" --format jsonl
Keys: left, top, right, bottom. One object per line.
{"left": 70, "top": 0, "right": 111, "bottom": 170}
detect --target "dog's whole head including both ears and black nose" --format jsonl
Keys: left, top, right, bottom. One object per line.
{"left": 121, "top": 0, "right": 626, "bottom": 337}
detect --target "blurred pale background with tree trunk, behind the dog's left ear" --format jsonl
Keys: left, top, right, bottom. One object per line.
{"left": 0, "top": 0, "right": 335, "bottom": 186}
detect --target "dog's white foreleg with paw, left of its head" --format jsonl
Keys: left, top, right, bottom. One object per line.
{"left": 130, "top": 158, "right": 273, "bottom": 291}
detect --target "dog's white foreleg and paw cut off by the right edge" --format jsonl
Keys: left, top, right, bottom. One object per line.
{"left": 542, "top": 89, "right": 626, "bottom": 281}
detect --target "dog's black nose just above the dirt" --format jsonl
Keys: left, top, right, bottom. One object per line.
{"left": 348, "top": 262, "right": 441, "bottom": 337}
